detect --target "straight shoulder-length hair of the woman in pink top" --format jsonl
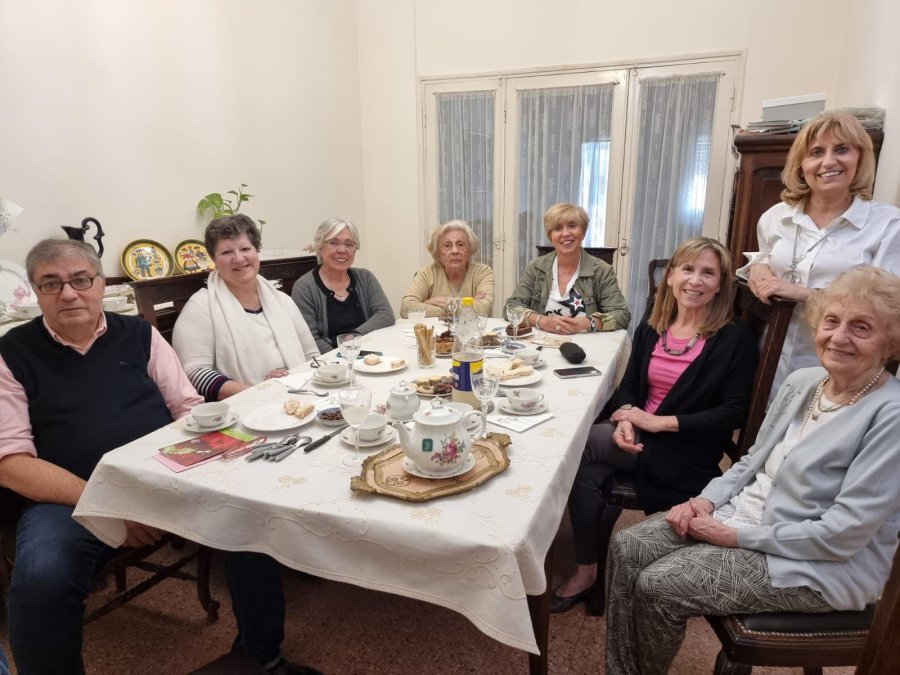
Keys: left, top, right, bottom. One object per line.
{"left": 647, "top": 237, "right": 734, "bottom": 337}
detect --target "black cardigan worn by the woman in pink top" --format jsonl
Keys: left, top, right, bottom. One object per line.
{"left": 614, "top": 321, "right": 759, "bottom": 513}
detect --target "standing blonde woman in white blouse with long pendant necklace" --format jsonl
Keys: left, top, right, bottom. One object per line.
{"left": 737, "top": 112, "right": 900, "bottom": 395}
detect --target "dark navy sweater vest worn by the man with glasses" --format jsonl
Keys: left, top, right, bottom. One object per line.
{"left": 0, "top": 313, "right": 172, "bottom": 480}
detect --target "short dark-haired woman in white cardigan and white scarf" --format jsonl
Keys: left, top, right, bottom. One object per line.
{"left": 172, "top": 214, "right": 319, "bottom": 401}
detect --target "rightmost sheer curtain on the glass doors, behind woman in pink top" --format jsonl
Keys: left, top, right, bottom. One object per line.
{"left": 624, "top": 73, "right": 720, "bottom": 322}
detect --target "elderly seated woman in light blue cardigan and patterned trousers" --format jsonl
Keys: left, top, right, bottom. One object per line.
{"left": 606, "top": 266, "right": 900, "bottom": 675}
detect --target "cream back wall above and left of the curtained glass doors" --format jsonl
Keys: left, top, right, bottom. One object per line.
{"left": 357, "top": 0, "right": 852, "bottom": 312}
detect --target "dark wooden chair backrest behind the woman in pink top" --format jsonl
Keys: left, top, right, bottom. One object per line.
{"left": 732, "top": 279, "right": 797, "bottom": 459}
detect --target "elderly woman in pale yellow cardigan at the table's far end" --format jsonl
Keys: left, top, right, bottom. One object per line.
{"left": 400, "top": 220, "right": 494, "bottom": 319}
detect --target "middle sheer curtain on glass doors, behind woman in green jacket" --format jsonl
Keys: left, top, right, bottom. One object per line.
{"left": 516, "top": 83, "right": 616, "bottom": 271}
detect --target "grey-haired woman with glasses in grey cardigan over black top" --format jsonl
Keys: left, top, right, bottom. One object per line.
{"left": 291, "top": 218, "right": 394, "bottom": 353}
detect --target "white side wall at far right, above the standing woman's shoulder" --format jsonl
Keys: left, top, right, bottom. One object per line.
{"left": 836, "top": 0, "right": 900, "bottom": 205}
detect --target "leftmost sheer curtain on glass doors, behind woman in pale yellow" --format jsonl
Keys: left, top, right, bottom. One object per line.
{"left": 437, "top": 91, "right": 496, "bottom": 265}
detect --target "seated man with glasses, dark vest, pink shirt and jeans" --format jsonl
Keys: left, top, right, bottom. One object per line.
{"left": 0, "top": 239, "right": 315, "bottom": 675}
